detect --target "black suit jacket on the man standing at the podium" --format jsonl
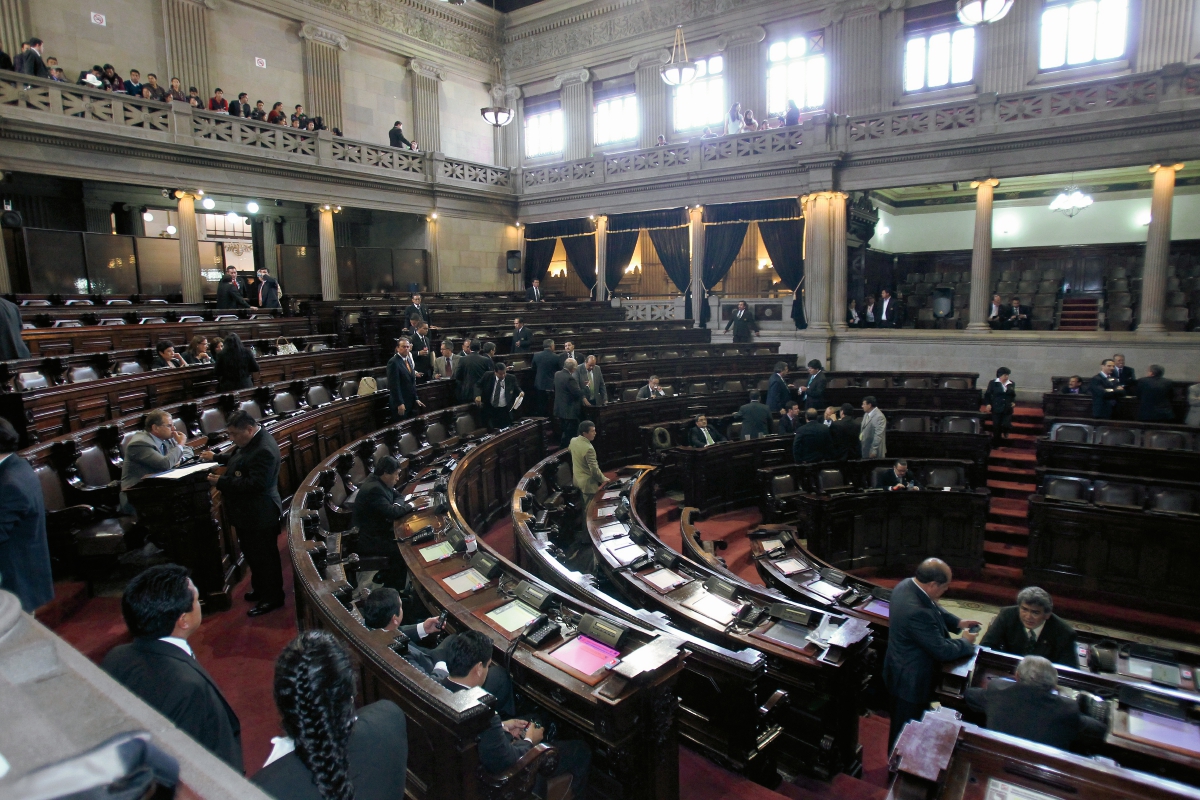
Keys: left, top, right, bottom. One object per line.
{"left": 217, "top": 428, "right": 283, "bottom": 534}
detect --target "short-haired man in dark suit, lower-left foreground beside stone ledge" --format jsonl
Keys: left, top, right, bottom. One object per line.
{"left": 101, "top": 564, "right": 242, "bottom": 774}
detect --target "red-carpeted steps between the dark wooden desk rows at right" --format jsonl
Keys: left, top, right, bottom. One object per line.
{"left": 983, "top": 404, "right": 1045, "bottom": 584}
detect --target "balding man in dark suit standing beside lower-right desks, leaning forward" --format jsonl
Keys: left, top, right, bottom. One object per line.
{"left": 883, "top": 559, "right": 980, "bottom": 752}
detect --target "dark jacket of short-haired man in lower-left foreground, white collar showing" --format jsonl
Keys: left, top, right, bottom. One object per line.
{"left": 100, "top": 637, "right": 242, "bottom": 774}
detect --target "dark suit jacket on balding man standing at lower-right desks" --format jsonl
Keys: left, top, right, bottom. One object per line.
{"left": 883, "top": 578, "right": 974, "bottom": 704}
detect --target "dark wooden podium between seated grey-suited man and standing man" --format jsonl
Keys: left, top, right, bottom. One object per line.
{"left": 126, "top": 470, "right": 242, "bottom": 610}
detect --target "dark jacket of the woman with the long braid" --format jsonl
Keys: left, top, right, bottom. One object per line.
{"left": 252, "top": 700, "right": 408, "bottom": 800}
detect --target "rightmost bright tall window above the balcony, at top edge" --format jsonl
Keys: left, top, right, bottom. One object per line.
{"left": 1039, "top": 0, "right": 1129, "bottom": 70}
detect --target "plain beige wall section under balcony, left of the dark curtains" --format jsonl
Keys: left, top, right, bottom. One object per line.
{"left": 437, "top": 216, "right": 517, "bottom": 291}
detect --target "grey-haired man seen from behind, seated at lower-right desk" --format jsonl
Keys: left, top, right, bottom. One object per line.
{"left": 966, "top": 656, "right": 1108, "bottom": 750}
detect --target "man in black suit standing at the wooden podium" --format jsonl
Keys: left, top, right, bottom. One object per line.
{"left": 200, "top": 410, "right": 283, "bottom": 616}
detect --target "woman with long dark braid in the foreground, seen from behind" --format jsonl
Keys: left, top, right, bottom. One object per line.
{"left": 252, "top": 631, "right": 408, "bottom": 800}
